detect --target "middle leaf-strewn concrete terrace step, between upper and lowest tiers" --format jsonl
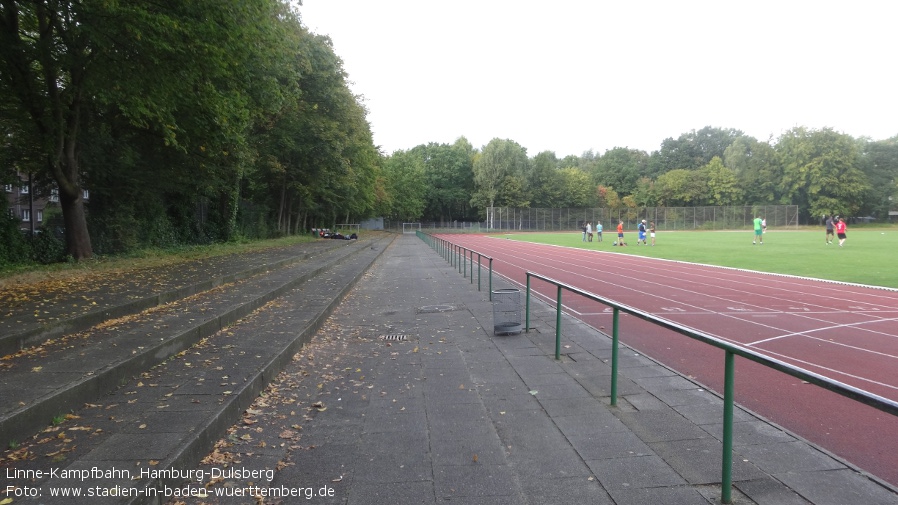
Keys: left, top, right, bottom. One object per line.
{"left": 0, "top": 239, "right": 387, "bottom": 452}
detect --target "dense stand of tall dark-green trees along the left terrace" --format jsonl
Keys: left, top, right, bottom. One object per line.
{"left": 0, "top": 0, "right": 387, "bottom": 259}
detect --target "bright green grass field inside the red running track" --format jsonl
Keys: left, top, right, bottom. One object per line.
{"left": 506, "top": 228, "right": 898, "bottom": 288}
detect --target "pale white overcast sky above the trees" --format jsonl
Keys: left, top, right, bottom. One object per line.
{"left": 299, "top": 0, "right": 898, "bottom": 158}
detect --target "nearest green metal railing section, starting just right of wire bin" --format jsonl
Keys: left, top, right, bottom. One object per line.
{"left": 524, "top": 272, "right": 898, "bottom": 503}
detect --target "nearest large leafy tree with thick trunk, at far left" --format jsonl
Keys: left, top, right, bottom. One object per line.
{"left": 0, "top": 0, "right": 284, "bottom": 259}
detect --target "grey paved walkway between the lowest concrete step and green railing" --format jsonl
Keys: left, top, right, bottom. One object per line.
{"left": 170, "top": 236, "right": 898, "bottom": 505}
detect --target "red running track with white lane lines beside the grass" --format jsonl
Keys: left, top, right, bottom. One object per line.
{"left": 441, "top": 235, "right": 898, "bottom": 485}
